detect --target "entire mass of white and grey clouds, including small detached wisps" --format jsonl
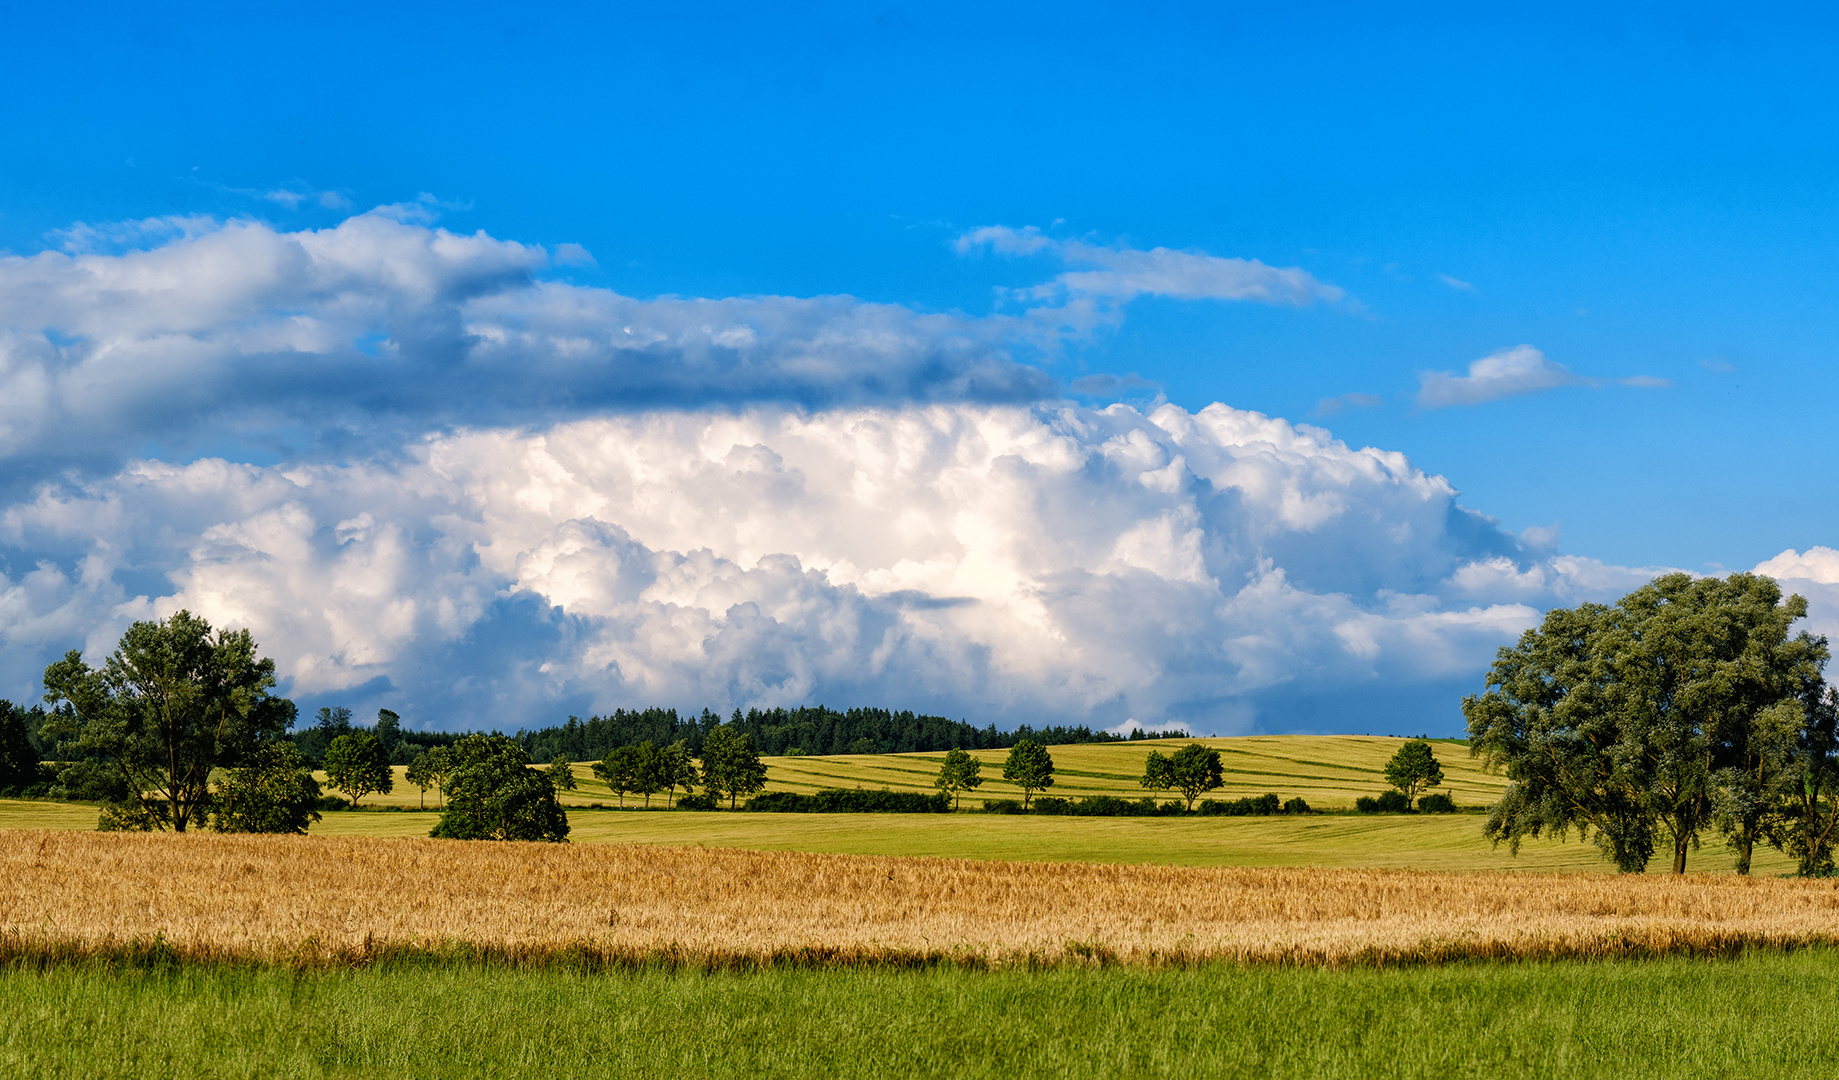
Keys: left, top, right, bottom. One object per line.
{"left": 0, "top": 208, "right": 1809, "bottom": 732}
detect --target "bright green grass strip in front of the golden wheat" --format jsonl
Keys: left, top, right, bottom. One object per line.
{"left": 0, "top": 951, "right": 1839, "bottom": 1078}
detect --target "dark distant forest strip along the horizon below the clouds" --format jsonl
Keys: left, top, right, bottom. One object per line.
{"left": 517, "top": 705, "right": 1188, "bottom": 762}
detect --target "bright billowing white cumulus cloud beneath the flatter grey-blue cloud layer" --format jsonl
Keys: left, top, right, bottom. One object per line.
{"left": 0, "top": 403, "right": 1662, "bottom": 730}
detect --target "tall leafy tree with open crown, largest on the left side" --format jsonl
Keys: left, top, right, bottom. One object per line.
{"left": 44, "top": 611, "right": 294, "bottom": 832}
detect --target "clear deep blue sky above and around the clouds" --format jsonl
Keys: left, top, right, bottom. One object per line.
{"left": 0, "top": 4, "right": 1839, "bottom": 735}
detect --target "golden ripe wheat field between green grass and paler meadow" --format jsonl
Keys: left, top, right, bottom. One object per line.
{"left": 0, "top": 830, "right": 1839, "bottom": 966}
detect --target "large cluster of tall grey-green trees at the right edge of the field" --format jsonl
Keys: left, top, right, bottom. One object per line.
{"left": 1462, "top": 574, "right": 1839, "bottom": 874}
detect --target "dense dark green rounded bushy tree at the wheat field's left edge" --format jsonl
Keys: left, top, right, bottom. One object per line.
{"left": 428, "top": 734, "right": 568, "bottom": 843}
